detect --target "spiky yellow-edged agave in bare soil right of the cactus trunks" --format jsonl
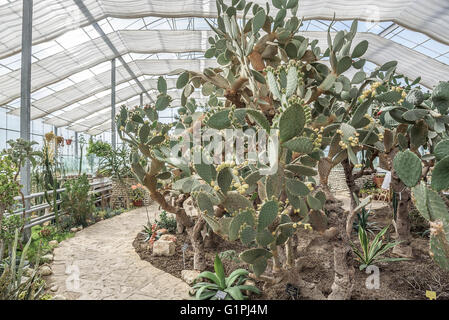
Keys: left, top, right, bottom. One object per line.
{"left": 351, "top": 226, "right": 408, "bottom": 270}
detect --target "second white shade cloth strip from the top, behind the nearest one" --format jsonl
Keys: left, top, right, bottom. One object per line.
{"left": 0, "top": 30, "right": 449, "bottom": 112}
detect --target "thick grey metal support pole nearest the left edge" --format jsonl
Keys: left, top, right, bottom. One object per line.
{"left": 20, "top": 0, "right": 33, "bottom": 239}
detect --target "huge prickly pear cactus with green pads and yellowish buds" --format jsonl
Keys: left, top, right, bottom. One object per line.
{"left": 117, "top": 0, "right": 449, "bottom": 276}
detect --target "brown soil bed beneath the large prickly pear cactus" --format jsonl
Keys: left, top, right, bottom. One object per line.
{"left": 133, "top": 208, "right": 449, "bottom": 300}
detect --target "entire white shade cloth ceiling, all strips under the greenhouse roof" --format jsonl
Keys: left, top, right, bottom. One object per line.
{"left": 0, "top": 0, "right": 449, "bottom": 135}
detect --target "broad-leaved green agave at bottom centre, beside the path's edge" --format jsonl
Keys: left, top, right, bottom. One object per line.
{"left": 189, "top": 254, "right": 260, "bottom": 300}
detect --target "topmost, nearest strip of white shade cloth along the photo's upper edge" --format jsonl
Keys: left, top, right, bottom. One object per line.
{"left": 0, "top": 0, "right": 449, "bottom": 59}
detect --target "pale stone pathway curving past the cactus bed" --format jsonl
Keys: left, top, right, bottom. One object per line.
{"left": 47, "top": 205, "right": 189, "bottom": 300}
